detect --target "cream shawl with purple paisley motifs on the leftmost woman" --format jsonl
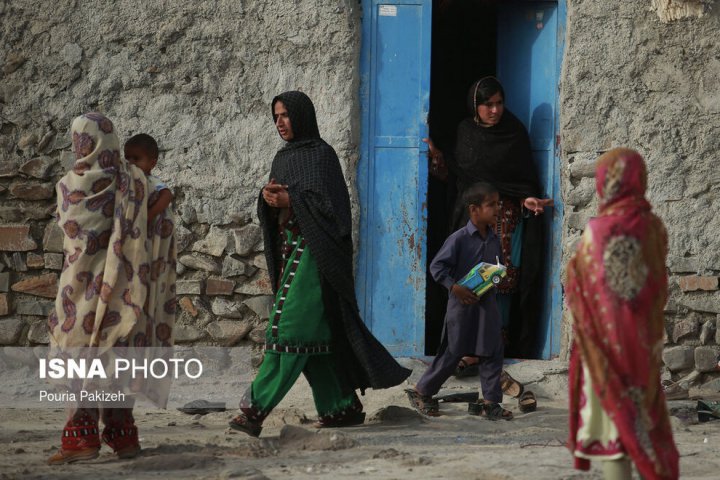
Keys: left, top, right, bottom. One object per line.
{"left": 49, "top": 113, "right": 149, "bottom": 351}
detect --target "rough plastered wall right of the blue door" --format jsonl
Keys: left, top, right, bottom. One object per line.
{"left": 560, "top": 0, "right": 720, "bottom": 391}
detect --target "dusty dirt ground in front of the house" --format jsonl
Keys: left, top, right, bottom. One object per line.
{"left": 0, "top": 360, "right": 720, "bottom": 480}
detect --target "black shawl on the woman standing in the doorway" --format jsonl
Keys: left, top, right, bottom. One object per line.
{"left": 448, "top": 80, "right": 545, "bottom": 358}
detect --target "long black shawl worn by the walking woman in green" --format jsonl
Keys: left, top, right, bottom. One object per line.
{"left": 258, "top": 91, "right": 410, "bottom": 391}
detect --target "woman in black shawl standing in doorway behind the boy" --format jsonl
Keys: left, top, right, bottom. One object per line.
{"left": 427, "top": 77, "right": 553, "bottom": 364}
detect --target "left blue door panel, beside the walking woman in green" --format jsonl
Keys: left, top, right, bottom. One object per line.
{"left": 356, "top": 0, "right": 432, "bottom": 356}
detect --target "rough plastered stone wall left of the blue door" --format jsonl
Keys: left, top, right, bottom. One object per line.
{"left": 0, "top": 0, "right": 360, "bottom": 364}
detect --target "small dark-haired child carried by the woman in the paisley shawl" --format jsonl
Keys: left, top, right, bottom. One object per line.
{"left": 125, "top": 133, "right": 173, "bottom": 228}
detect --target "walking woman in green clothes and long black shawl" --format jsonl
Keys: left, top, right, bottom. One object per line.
{"left": 230, "top": 92, "right": 410, "bottom": 436}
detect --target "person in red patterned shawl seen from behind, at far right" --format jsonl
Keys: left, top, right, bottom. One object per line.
{"left": 565, "top": 148, "right": 678, "bottom": 479}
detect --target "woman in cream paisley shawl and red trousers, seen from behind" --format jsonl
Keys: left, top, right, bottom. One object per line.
{"left": 48, "top": 113, "right": 175, "bottom": 465}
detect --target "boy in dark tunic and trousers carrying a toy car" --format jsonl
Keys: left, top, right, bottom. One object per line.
{"left": 406, "top": 182, "right": 512, "bottom": 420}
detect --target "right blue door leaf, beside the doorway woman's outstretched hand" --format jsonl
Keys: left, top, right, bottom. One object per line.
{"left": 497, "top": 1, "right": 565, "bottom": 358}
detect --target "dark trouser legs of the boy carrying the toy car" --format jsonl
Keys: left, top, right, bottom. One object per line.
{"left": 415, "top": 342, "right": 503, "bottom": 403}
